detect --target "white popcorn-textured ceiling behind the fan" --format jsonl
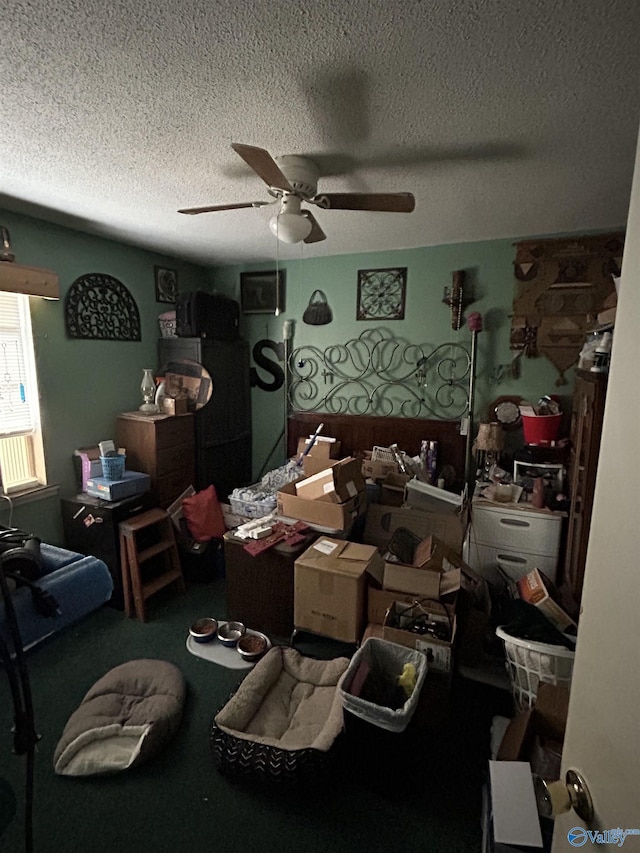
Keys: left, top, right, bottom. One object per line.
{"left": 0, "top": 0, "right": 640, "bottom": 264}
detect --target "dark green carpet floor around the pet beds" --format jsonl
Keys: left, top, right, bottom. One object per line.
{"left": 0, "top": 578, "right": 509, "bottom": 853}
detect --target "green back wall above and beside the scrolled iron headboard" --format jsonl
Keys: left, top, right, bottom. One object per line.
{"left": 213, "top": 240, "right": 573, "bottom": 478}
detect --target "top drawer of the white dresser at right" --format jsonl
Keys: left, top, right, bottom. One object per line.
{"left": 470, "top": 505, "right": 562, "bottom": 561}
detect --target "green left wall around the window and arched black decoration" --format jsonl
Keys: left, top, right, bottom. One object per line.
{"left": 0, "top": 206, "right": 208, "bottom": 544}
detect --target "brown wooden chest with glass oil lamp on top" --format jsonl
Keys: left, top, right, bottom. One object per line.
{"left": 116, "top": 412, "right": 195, "bottom": 507}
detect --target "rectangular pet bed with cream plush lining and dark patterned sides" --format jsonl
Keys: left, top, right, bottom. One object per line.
{"left": 210, "top": 646, "right": 349, "bottom": 782}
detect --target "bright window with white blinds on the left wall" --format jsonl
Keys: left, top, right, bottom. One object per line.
{"left": 0, "top": 292, "right": 46, "bottom": 494}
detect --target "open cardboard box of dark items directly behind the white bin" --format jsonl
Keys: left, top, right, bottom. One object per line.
{"left": 382, "top": 596, "right": 457, "bottom": 673}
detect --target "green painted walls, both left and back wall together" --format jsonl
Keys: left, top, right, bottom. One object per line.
{"left": 0, "top": 203, "right": 600, "bottom": 543}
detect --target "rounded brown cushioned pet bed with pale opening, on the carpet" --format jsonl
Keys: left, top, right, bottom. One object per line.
{"left": 53, "top": 659, "right": 185, "bottom": 776}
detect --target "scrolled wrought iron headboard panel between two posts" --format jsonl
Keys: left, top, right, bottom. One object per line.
{"left": 288, "top": 328, "right": 471, "bottom": 420}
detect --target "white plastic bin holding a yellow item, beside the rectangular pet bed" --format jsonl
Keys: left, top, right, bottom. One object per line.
{"left": 338, "top": 637, "right": 427, "bottom": 732}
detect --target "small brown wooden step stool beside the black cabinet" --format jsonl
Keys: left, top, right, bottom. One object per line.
{"left": 119, "top": 507, "right": 184, "bottom": 622}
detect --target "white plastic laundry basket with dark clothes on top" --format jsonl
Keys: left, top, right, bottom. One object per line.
{"left": 496, "top": 627, "right": 575, "bottom": 711}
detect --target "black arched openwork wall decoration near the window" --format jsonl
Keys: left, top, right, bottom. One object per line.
{"left": 64, "top": 273, "right": 142, "bottom": 341}
